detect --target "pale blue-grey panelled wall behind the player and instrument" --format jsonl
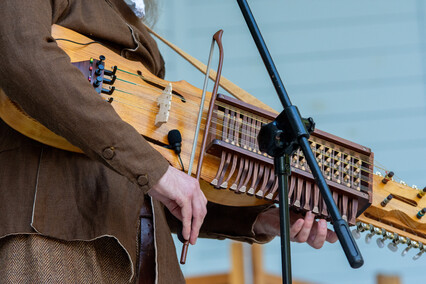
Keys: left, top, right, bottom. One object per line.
{"left": 151, "top": 0, "right": 426, "bottom": 284}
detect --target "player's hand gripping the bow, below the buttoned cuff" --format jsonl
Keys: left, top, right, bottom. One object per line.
{"left": 148, "top": 166, "right": 207, "bottom": 245}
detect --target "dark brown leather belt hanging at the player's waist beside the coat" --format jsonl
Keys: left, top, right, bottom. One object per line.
{"left": 138, "top": 195, "right": 155, "bottom": 284}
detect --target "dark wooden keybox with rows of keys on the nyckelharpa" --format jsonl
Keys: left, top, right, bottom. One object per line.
{"left": 207, "top": 94, "right": 373, "bottom": 225}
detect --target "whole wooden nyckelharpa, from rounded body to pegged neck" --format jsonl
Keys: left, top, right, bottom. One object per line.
{"left": 0, "top": 26, "right": 426, "bottom": 255}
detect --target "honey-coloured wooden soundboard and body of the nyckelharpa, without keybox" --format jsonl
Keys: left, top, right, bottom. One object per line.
{"left": 0, "top": 25, "right": 268, "bottom": 206}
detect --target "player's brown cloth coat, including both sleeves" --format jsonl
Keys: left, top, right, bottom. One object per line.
{"left": 0, "top": 0, "right": 271, "bottom": 283}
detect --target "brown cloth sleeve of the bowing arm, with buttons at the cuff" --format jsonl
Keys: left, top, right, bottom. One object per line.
{"left": 0, "top": 0, "right": 168, "bottom": 192}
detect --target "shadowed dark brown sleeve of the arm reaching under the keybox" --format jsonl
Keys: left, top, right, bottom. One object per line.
{"left": 165, "top": 202, "right": 275, "bottom": 243}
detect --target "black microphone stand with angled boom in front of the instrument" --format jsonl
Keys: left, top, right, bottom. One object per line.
{"left": 237, "top": 0, "right": 364, "bottom": 284}
